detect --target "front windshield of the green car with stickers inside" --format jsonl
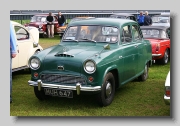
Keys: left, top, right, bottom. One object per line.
{"left": 62, "top": 25, "right": 119, "bottom": 43}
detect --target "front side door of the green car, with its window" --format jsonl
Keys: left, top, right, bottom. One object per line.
{"left": 121, "top": 24, "right": 138, "bottom": 83}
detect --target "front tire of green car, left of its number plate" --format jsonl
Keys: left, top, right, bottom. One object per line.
{"left": 34, "top": 86, "right": 48, "bottom": 101}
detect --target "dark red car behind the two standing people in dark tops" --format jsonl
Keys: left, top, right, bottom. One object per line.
{"left": 25, "top": 14, "right": 60, "bottom": 37}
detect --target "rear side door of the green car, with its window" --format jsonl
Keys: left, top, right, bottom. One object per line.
{"left": 132, "top": 24, "right": 147, "bottom": 73}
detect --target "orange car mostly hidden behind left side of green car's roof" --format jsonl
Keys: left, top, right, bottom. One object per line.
{"left": 59, "top": 17, "right": 95, "bottom": 36}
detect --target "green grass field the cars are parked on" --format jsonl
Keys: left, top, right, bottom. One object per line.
{"left": 10, "top": 36, "right": 170, "bottom": 116}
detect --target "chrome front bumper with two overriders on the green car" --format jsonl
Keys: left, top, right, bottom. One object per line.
{"left": 28, "top": 80, "right": 101, "bottom": 95}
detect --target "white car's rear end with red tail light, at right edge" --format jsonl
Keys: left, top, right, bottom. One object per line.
{"left": 164, "top": 71, "right": 171, "bottom": 105}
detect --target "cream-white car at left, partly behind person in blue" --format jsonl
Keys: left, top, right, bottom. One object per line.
{"left": 11, "top": 21, "right": 43, "bottom": 72}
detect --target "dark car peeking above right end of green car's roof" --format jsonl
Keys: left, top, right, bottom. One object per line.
{"left": 110, "top": 13, "right": 137, "bottom": 21}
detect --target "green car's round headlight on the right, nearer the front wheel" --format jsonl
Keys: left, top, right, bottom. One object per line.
{"left": 84, "top": 60, "right": 96, "bottom": 74}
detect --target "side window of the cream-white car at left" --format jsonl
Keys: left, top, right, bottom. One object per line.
{"left": 14, "top": 26, "right": 29, "bottom": 40}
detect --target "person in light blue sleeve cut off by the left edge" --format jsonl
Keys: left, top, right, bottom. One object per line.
{"left": 10, "top": 21, "right": 17, "bottom": 103}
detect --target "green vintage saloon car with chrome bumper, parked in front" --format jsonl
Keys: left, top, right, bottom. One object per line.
{"left": 28, "top": 18, "right": 152, "bottom": 106}
